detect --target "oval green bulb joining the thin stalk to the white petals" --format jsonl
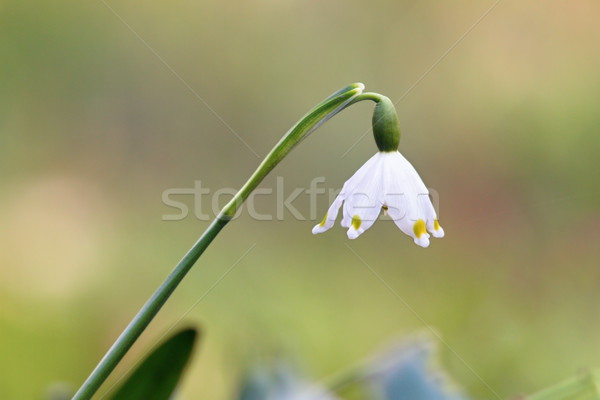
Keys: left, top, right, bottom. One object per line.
{"left": 373, "top": 96, "right": 400, "bottom": 153}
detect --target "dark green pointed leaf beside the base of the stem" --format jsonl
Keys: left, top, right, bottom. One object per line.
{"left": 110, "top": 328, "right": 198, "bottom": 400}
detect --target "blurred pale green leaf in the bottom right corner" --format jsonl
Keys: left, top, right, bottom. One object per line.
{"left": 525, "top": 370, "right": 600, "bottom": 400}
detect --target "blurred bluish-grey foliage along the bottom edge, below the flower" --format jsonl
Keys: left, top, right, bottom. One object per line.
{"left": 236, "top": 340, "right": 467, "bottom": 400}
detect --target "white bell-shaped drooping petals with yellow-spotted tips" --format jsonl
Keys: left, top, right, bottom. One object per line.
{"left": 312, "top": 151, "right": 444, "bottom": 247}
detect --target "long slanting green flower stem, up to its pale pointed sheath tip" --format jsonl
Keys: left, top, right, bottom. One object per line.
{"left": 73, "top": 83, "right": 364, "bottom": 400}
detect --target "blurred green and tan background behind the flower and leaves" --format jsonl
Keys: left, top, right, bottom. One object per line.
{"left": 0, "top": 0, "right": 600, "bottom": 399}
